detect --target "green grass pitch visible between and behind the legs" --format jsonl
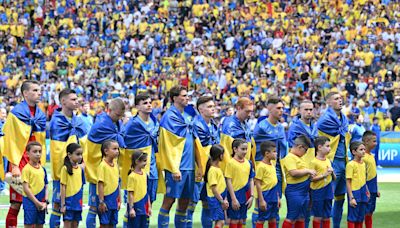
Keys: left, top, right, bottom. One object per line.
{"left": 0, "top": 183, "right": 400, "bottom": 228}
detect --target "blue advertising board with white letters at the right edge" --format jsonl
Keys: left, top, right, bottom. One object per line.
{"left": 378, "top": 131, "right": 400, "bottom": 166}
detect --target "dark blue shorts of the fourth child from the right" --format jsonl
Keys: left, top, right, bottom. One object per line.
{"left": 286, "top": 194, "right": 310, "bottom": 220}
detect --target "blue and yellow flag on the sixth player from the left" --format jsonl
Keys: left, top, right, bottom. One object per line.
{"left": 193, "top": 115, "right": 220, "bottom": 175}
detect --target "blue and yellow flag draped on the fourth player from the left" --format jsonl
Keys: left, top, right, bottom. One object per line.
{"left": 120, "top": 115, "right": 160, "bottom": 189}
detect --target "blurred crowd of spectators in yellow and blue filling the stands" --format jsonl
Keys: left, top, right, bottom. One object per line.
{"left": 0, "top": 0, "right": 400, "bottom": 131}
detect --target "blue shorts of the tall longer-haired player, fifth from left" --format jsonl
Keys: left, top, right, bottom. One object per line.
{"left": 165, "top": 170, "right": 195, "bottom": 199}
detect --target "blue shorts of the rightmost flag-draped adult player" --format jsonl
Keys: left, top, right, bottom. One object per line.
{"left": 332, "top": 158, "right": 346, "bottom": 196}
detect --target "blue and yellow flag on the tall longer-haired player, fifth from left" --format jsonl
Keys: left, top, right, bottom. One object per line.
{"left": 158, "top": 105, "right": 193, "bottom": 173}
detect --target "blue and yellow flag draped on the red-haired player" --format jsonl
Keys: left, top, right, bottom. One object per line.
{"left": 220, "top": 115, "right": 256, "bottom": 170}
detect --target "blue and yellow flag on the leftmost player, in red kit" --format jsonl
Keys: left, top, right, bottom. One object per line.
{"left": 3, "top": 101, "right": 46, "bottom": 165}
